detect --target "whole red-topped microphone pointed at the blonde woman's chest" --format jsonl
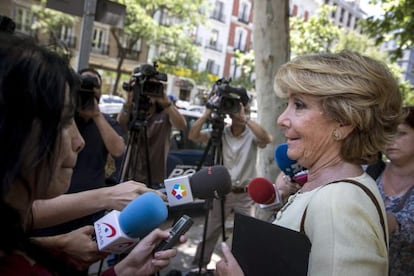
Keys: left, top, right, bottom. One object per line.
{"left": 247, "top": 177, "right": 282, "bottom": 209}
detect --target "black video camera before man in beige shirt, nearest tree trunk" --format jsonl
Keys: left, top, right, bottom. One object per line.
{"left": 206, "top": 78, "right": 249, "bottom": 114}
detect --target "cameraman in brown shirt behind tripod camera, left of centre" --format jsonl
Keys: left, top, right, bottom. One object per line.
{"left": 117, "top": 71, "right": 187, "bottom": 188}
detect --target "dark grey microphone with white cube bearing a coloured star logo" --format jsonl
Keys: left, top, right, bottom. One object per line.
{"left": 164, "top": 165, "right": 231, "bottom": 206}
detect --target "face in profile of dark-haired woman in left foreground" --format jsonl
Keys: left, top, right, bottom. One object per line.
{"left": 46, "top": 88, "right": 85, "bottom": 198}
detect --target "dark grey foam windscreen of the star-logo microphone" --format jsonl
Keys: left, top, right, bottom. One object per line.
{"left": 190, "top": 165, "right": 231, "bottom": 199}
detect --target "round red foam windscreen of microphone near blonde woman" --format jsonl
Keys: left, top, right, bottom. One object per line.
{"left": 247, "top": 177, "right": 276, "bottom": 204}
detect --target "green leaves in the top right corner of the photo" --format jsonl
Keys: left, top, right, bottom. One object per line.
{"left": 361, "top": 0, "right": 414, "bottom": 60}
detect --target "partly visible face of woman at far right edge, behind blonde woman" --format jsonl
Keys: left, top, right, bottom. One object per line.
{"left": 385, "top": 124, "right": 414, "bottom": 164}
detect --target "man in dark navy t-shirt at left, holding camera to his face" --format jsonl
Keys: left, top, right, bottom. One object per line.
{"left": 35, "top": 68, "right": 125, "bottom": 275}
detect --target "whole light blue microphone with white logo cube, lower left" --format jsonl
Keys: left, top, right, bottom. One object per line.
{"left": 94, "top": 192, "right": 168, "bottom": 254}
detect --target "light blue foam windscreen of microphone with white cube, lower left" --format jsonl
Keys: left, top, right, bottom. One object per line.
{"left": 119, "top": 192, "right": 168, "bottom": 238}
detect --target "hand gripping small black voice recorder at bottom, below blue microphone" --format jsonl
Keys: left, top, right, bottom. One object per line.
{"left": 114, "top": 228, "right": 187, "bottom": 276}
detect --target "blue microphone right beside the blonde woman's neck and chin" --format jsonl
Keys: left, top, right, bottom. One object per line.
{"left": 275, "top": 143, "right": 308, "bottom": 185}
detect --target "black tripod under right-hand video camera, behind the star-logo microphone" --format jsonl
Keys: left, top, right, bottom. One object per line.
{"left": 197, "top": 114, "right": 227, "bottom": 275}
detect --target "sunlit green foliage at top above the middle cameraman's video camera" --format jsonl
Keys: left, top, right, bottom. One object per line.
{"left": 113, "top": 0, "right": 205, "bottom": 67}
